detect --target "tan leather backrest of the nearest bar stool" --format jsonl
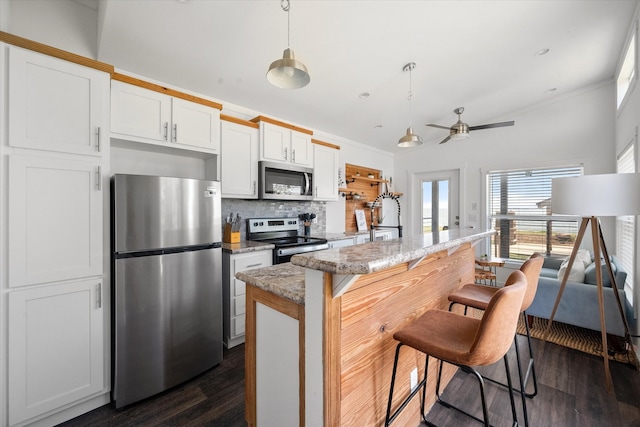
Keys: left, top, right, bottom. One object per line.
{"left": 469, "top": 270, "right": 527, "bottom": 366}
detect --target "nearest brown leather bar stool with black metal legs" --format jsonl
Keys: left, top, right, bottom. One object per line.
{"left": 385, "top": 270, "right": 527, "bottom": 427}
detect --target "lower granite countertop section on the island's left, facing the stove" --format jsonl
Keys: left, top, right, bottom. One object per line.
{"left": 236, "top": 262, "right": 304, "bottom": 305}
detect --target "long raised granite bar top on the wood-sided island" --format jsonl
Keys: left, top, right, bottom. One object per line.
{"left": 291, "top": 229, "right": 495, "bottom": 275}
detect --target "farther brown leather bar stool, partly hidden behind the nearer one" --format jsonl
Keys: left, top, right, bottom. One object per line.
{"left": 449, "top": 253, "right": 544, "bottom": 425}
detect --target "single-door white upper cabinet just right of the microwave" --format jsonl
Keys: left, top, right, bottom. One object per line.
{"left": 312, "top": 144, "right": 339, "bottom": 201}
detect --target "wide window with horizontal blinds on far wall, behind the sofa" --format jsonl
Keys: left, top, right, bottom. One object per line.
{"left": 487, "top": 166, "right": 582, "bottom": 261}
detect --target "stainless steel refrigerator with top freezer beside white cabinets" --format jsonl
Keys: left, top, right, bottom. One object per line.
{"left": 111, "top": 174, "right": 222, "bottom": 408}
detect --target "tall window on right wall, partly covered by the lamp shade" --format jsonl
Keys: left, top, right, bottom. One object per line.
{"left": 616, "top": 143, "right": 636, "bottom": 307}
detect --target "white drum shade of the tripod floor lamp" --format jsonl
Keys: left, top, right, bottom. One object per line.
{"left": 551, "top": 173, "right": 640, "bottom": 217}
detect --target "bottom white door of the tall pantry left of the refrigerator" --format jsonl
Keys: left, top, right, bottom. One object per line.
{"left": 8, "top": 280, "right": 104, "bottom": 425}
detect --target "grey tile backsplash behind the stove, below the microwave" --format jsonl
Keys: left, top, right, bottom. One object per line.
{"left": 222, "top": 199, "right": 327, "bottom": 240}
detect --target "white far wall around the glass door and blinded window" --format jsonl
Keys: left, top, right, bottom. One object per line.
{"left": 394, "top": 82, "right": 615, "bottom": 244}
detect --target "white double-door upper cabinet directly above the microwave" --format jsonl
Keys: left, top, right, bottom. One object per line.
{"left": 260, "top": 121, "right": 313, "bottom": 167}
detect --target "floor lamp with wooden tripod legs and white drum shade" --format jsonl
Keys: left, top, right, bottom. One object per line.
{"left": 544, "top": 173, "right": 640, "bottom": 390}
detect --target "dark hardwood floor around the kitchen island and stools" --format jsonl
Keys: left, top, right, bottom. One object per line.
{"left": 61, "top": 337, "right": 640, "bottom": 427}
